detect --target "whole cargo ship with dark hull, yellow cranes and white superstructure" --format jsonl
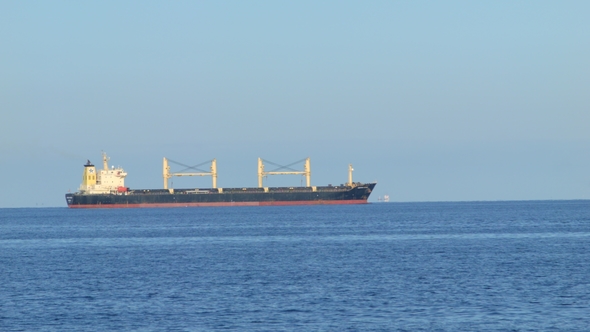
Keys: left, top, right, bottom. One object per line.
{"left": 66, "top": 153, "right": 376, "bottom": 208}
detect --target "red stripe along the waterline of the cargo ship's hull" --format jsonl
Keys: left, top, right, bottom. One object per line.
{"left": 68, "top": 199, "right": 367, "bottom": 209}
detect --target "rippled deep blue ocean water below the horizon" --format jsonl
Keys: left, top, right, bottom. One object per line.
{"left": 0, "top": 201, "right": 590, "bottom": 331}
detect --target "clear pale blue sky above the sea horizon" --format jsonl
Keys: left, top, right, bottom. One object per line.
{"left": 0, "top": 0, "right": 590, "bottom": 208}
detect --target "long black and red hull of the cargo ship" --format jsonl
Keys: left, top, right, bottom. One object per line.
{"left": 66, "top": 183, "right": 375, "bottom": 208}
